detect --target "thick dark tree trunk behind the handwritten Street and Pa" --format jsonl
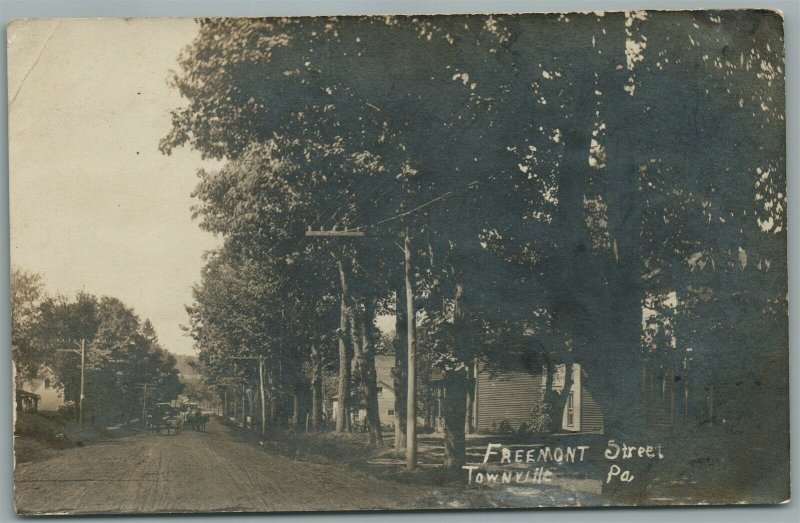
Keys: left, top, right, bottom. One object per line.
{"left": 587, "top": 40, "right": 653, "bottom": 504}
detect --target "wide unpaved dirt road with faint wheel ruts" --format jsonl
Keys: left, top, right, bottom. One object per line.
{"left": 15, "top": 420, "right": 438, "bottom": 514}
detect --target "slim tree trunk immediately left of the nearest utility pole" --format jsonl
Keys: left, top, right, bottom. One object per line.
{"left": 392, "top": 271, "right": 408, "bottom": 449}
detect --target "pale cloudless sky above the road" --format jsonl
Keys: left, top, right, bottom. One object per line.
{"left": 8, "top": 19, "right": 220, "bottom": 354}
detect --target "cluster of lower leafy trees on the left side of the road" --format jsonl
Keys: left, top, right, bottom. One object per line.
{"left": 12, "top": 268, "right": 182, "bottom": 423}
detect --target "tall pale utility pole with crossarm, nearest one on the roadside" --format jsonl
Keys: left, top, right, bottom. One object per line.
{"left": 306, "top": 227, "right": 417, "bottom": 471}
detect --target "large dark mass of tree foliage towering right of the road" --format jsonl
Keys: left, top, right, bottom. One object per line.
{"left": 162, "top": 12, "right": 787, "bottom": 478}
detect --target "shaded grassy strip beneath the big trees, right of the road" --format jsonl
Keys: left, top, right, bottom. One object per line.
{"left": 229, "top": 423, "right": 788, "bottom": 507}
